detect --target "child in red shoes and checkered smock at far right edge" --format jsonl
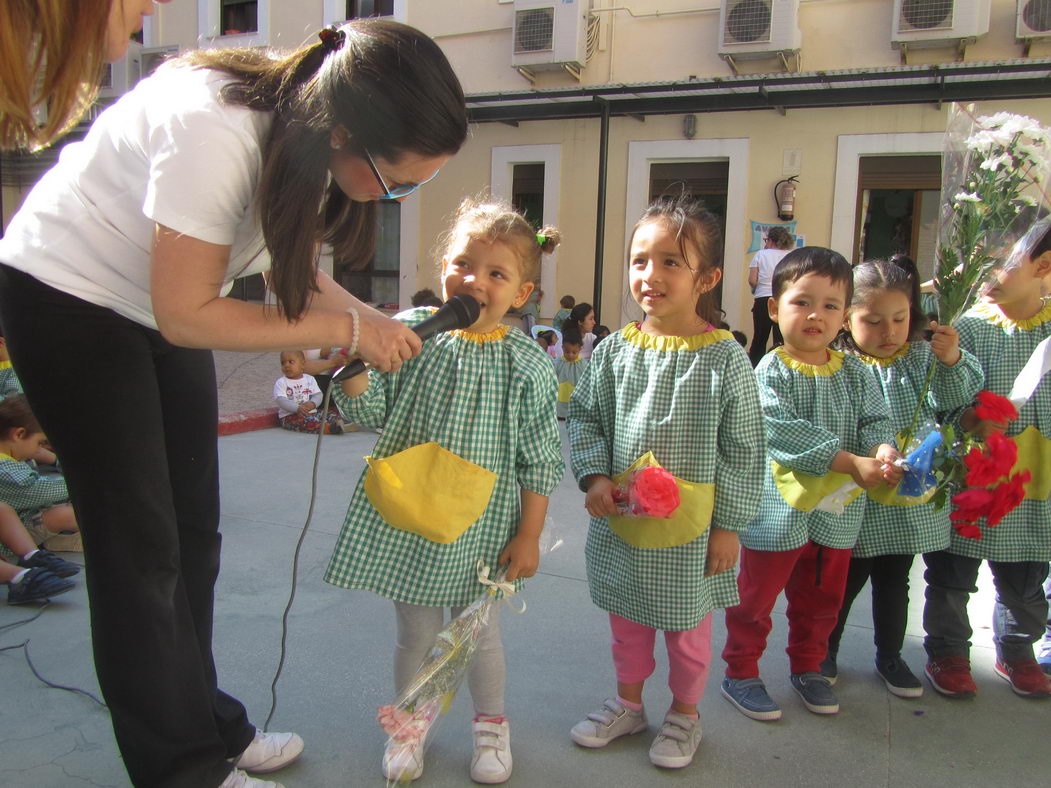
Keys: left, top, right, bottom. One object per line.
{"left": 924, "top": 220, "right": 1051, "bottom": 698}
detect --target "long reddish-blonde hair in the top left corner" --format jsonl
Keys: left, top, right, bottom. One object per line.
{"left": 0, "top": 0, "right": 108, "bottom": 150}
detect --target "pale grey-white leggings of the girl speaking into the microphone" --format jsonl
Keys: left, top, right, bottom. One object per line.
{"left": 394, "top": 602, "right": 507, "bottom": 717}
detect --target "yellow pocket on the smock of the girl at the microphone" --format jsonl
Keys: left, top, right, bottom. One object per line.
{"left": 365, "top": 441, "right": 496, "bottom": 544}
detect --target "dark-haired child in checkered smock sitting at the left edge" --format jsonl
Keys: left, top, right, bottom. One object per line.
{"left": 0, "top": 394, "right": 80, "bottom": 548}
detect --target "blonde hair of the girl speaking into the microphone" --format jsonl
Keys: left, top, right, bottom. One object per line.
{"left": 438, "top": 198, "right": 562, "bottom": 282}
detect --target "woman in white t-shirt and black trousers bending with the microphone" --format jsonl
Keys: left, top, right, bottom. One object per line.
{"left": 0, "top": 19, "right": 467, "bottom": 788}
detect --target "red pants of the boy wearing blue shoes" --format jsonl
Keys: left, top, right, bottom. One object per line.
{"left": 723, "top": 542, "right": 850, "bottom": 679}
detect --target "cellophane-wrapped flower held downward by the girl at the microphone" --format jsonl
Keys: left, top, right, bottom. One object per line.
{"left": 376, "top": 517, "right": 563, "bottom": 788}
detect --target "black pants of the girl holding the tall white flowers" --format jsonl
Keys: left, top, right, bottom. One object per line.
{"left": 828, "top": 555, "right": 915, "bottom": 659}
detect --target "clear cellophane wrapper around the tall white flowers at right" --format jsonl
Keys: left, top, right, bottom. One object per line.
{"left": 934, "top": 103, "right": 1051, "bottom": 325}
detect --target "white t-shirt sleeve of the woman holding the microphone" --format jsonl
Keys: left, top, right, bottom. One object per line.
{"left": 142, "top": 74, "right": 262, "bottom": 246}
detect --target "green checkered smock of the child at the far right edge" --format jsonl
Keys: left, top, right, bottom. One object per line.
{"left": 949, "top": 303, "right": 1051, "bottom": 561}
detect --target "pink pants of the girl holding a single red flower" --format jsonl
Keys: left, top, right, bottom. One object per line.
{"left": 610, "top": 613, "right": 712, "bottom": 704}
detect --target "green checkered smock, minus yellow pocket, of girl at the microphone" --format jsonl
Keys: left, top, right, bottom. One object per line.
{"left": 325, "top": 308, "right": 564, "bottom": 605}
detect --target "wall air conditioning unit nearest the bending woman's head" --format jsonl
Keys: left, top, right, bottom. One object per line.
{"left": 511, "top": 0, "right": 589, "bottom": 76}
